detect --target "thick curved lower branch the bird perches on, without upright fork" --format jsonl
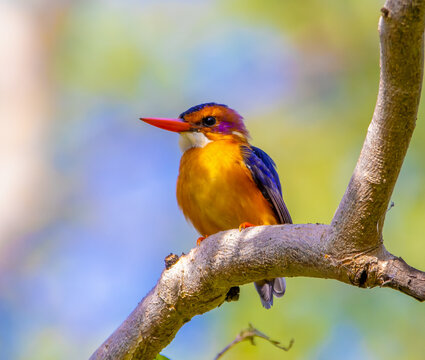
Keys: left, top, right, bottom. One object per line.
{"left": 88, "top": 224, "right": 425, "bottom": 359}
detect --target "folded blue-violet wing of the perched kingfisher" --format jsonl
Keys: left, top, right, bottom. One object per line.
{"left": 241, "top": 145, "right": 292, "bottom": 224}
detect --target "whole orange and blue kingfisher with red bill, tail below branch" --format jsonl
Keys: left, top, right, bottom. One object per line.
{"left": 140, "top": 102, "right": 292, "bottom": 309}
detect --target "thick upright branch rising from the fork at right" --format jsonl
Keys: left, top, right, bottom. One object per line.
{"left": 332, "top": 0, "right": 425, "bottom": 254}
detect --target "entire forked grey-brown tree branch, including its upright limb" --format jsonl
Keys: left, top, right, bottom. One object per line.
{"left": 91, "top": 0, "right": 425, "bottom": 360}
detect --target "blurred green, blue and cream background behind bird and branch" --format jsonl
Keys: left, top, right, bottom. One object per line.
{"left": 0, "top": 0, "right": 425, "bottom": 360}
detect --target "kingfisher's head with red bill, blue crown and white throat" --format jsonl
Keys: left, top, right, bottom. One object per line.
{"left": 140, "top": 103, "right": 249, "bottom": 151}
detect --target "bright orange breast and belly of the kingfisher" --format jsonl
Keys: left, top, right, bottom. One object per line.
{"left": 177, "top": 140, "right": 278, "bottom": 235}
